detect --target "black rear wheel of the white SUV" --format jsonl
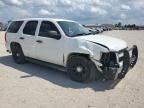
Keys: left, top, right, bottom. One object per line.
{"left": 11, "top": 45, "right": 26, "bottom": 64}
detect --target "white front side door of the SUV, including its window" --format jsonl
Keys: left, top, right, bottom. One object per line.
{"left": 36, "top": 21, "right": 64, "bottom": 65}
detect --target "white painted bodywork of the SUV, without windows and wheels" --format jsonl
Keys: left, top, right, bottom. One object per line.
{"left": 6, "top": 18, "right": 127, "bottom": 66}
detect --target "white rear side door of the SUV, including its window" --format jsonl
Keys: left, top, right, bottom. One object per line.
{"left": 19, "top": 20, "right": 38, "bottom": 58}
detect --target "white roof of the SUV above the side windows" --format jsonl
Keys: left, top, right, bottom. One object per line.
{"left": 12, "top": 18, "right": 75, "bottom": 22}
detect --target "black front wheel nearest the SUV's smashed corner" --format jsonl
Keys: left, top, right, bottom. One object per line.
{"left": 67, "top": 56, "right": 99, "bottom": 82}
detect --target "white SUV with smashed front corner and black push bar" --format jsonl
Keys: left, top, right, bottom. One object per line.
{"left": 5, "top": 18, "right": 138, "bottom": 82}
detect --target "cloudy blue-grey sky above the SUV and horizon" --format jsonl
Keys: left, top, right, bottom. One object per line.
{"left": 0, "top": 0, "right": 144, "bottom": 25}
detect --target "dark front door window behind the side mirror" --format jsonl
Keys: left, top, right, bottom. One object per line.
{"left": 39, "top": 21, "right": 60, "bottom": 37}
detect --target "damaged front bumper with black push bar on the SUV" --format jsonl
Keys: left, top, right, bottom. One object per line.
{"left": 100, "top": 45, "right": 138, "bottom": 80}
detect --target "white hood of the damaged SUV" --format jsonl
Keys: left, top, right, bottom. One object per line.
{"left": 76, "top": 35, "right": 127, "bottom": 51}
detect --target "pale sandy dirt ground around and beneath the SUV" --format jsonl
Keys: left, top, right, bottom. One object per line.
{"left": 0, "top": 31, "right": 144, "bottom": 108}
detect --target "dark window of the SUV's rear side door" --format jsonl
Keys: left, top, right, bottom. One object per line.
{"left": 23, "top": 21, "right": 38, "bottom": 35}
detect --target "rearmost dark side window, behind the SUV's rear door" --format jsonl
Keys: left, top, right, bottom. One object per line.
{"left": 7, "top": 21, "right": 23, "bottom": 33}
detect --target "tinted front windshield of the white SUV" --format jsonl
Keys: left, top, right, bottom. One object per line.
{"left": 58, "top": 21, "right": 91, "bottom": 37}
